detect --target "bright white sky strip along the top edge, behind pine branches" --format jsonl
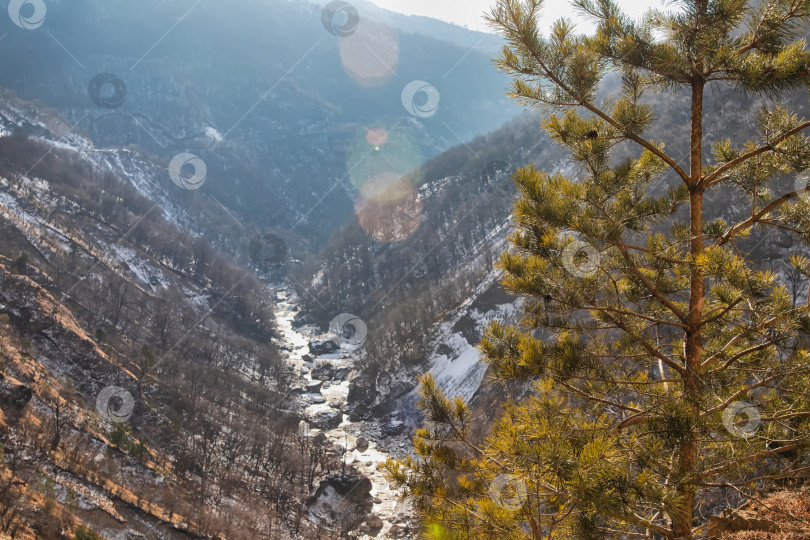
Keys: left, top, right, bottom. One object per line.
{"left": 372, "top": 0, "right": 662, "bottom": 31}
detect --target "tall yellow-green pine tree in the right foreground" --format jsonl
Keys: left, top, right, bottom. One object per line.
{"left": 388, "top": 0, "right": 810, "bottom": 539}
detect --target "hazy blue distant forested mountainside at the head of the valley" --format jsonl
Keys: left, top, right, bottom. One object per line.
{"left": 0, "top": 0, "right": 518, "bottom": 241}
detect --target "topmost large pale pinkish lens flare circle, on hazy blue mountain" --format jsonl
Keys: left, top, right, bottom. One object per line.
{"left": 338, "top": 19, "right": 399, "bottom": 87}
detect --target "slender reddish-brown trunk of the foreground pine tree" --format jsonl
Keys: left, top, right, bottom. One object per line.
{"left": 672, "top": 74, "right": 706, "bottom": 539}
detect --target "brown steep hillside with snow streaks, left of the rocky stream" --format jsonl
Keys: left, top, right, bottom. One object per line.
{"left": 0, "top": 102, "right": 407, "bottom": 539}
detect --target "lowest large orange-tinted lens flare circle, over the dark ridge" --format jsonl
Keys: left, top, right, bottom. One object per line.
{"left": 355, "top": 173, "right": 422, "bottom": 242}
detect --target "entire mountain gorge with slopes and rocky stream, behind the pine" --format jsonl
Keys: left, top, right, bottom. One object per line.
{"left": 0, "top": 0, "right": 806, "bottom": 539}
